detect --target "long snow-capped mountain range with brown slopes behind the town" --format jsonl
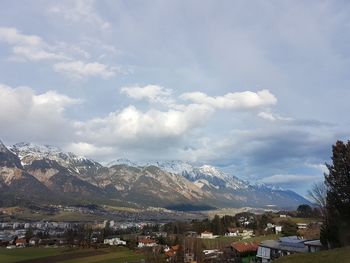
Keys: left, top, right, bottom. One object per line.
{"left": 0, "top": 142, "right": 309, "bottom": 209}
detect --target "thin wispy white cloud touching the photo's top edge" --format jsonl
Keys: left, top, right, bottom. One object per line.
{"left": 49, "top": 0, "right": 111, "bottom": 30}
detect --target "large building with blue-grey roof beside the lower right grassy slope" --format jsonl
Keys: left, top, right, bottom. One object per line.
{"left": 256, "top": 236, "right": 308, "bottom": 263}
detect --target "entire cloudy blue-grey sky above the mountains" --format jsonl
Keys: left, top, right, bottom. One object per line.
{"left": 0, "top": 0, "right": 350, "bottom": 194}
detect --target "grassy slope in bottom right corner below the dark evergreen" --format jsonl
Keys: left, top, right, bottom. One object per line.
{"left": 274, "top": 247, "right": 350, "bottom": 263}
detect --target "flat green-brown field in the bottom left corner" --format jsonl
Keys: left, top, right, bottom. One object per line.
{"left": 0, "top": 248, "right": 143, "bottom": 263}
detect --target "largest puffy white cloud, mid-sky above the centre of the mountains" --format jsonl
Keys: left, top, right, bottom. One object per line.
{"left": 76, "top": 104, "right": 212, "bottom": 147}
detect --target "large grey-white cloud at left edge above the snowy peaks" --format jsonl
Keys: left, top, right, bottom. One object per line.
{"left": 0, "top": 84, "right": 81, "bottom": 141}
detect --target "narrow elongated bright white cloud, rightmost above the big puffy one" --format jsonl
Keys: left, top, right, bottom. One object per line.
{"left": 180, "top": 90, "right": 277, "bottom": 110}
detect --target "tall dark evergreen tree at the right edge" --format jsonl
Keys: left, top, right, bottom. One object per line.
{"left": 321, "top": 141, "right": 350, "bottom": 248}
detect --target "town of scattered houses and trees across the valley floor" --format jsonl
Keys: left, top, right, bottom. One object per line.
{"left": 0, "top": 205, "right": 323, "bottom": 263}
